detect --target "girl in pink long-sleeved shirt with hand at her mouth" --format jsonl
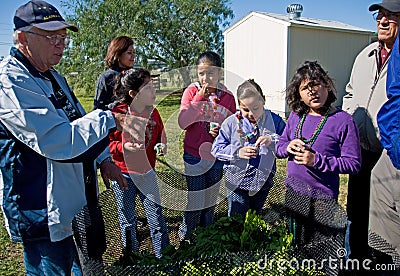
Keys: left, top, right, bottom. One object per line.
{"left": 178, "top": 51, "right": 236, "bottom": 239}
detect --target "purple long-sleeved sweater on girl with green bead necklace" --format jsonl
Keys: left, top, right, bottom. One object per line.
{"left": 276, "top": 110, "right": 361, "bottom": 199}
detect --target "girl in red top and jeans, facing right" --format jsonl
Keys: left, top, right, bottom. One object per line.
{"left": 109, "top": 69, "right": 169, "bottom": 258}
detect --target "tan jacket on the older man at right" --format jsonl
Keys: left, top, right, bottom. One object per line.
{"left": 342, "top": 42, "right": 390, "bottom": 152}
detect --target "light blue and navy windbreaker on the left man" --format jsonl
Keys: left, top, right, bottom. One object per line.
{"left": 0, "top": 48, "right": 115, "bottom": 241}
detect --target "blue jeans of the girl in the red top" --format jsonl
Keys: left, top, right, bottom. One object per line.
{"left": 112, "top": 170, "right": 169, "bottom": 258}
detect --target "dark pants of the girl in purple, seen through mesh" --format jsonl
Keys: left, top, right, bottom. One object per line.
{"left": 285, "top": 187, "right": 347, "bottom": 275}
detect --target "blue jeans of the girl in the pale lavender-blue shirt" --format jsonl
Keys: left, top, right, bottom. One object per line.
{"left": 227, "top": 175, "right": 273, "bottom": 218}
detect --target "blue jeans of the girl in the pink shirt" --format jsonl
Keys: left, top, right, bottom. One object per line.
{"left": 179, "top": 153, "right": 223, "bottom": 240}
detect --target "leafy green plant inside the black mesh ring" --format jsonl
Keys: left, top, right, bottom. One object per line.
{"left": 111, "top": 210, "right": 325, "bottom": 276}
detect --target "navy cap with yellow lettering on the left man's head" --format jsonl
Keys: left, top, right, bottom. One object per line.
{"left": 14, "top": 0, "right": 79, "bottom": 32}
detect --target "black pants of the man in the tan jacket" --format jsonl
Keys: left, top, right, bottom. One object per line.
{"left": 347, "top": 149, "right": 381, "bottom": 260}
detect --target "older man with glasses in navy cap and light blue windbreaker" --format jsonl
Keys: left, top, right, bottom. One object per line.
{"left": 0, "top": 0, "right": 127, "bottom": 275}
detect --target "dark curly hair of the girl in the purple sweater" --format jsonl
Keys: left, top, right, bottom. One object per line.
{"left": 286, "top": 61, "right": 336, "bottom": 116}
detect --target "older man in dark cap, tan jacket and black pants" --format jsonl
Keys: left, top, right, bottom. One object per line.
{"left": 343, "top": 0, "right": 400, "bottom": 270}
